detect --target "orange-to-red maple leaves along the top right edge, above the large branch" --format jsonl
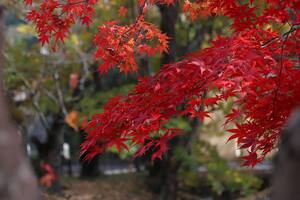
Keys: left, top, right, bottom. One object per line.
{"left": 183, "top": 0, "right": 299, "bottom": 28}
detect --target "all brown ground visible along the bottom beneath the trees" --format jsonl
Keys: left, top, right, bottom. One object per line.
{"left": 42, "top": 173, "right": 270, "bottom": 200}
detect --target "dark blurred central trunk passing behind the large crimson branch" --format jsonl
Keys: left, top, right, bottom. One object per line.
{"left": 148, "top": 4, "right": 180, "bottom": 200}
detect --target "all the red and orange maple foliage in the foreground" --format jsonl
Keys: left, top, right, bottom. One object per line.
{"left": 24, "top": 0, "right": 300, "bottom": 166}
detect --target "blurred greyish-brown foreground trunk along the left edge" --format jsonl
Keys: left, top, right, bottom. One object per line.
{"left": 0, "top": 5, "right": 39, "bottom": 200}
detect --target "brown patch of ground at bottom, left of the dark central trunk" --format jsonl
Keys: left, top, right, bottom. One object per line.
{"left": 43, "top": 174, "right": 155, "bottom": 200}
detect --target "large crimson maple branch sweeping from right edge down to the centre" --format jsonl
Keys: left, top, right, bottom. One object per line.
{"left": 82, "top": 27, "right": 300, "bottom": 165}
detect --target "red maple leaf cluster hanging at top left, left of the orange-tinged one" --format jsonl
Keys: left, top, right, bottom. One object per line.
{"left": 24, "top": 0, "right": 97, "bottom": 49}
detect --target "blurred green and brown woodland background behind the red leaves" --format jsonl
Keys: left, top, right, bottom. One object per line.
{"left": 4, "top": 0, "right": 273, "bottom": 200}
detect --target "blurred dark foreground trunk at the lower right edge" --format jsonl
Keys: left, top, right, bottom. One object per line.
{"left": 272, "top": 109, "right": 300, "bottom": 200}
